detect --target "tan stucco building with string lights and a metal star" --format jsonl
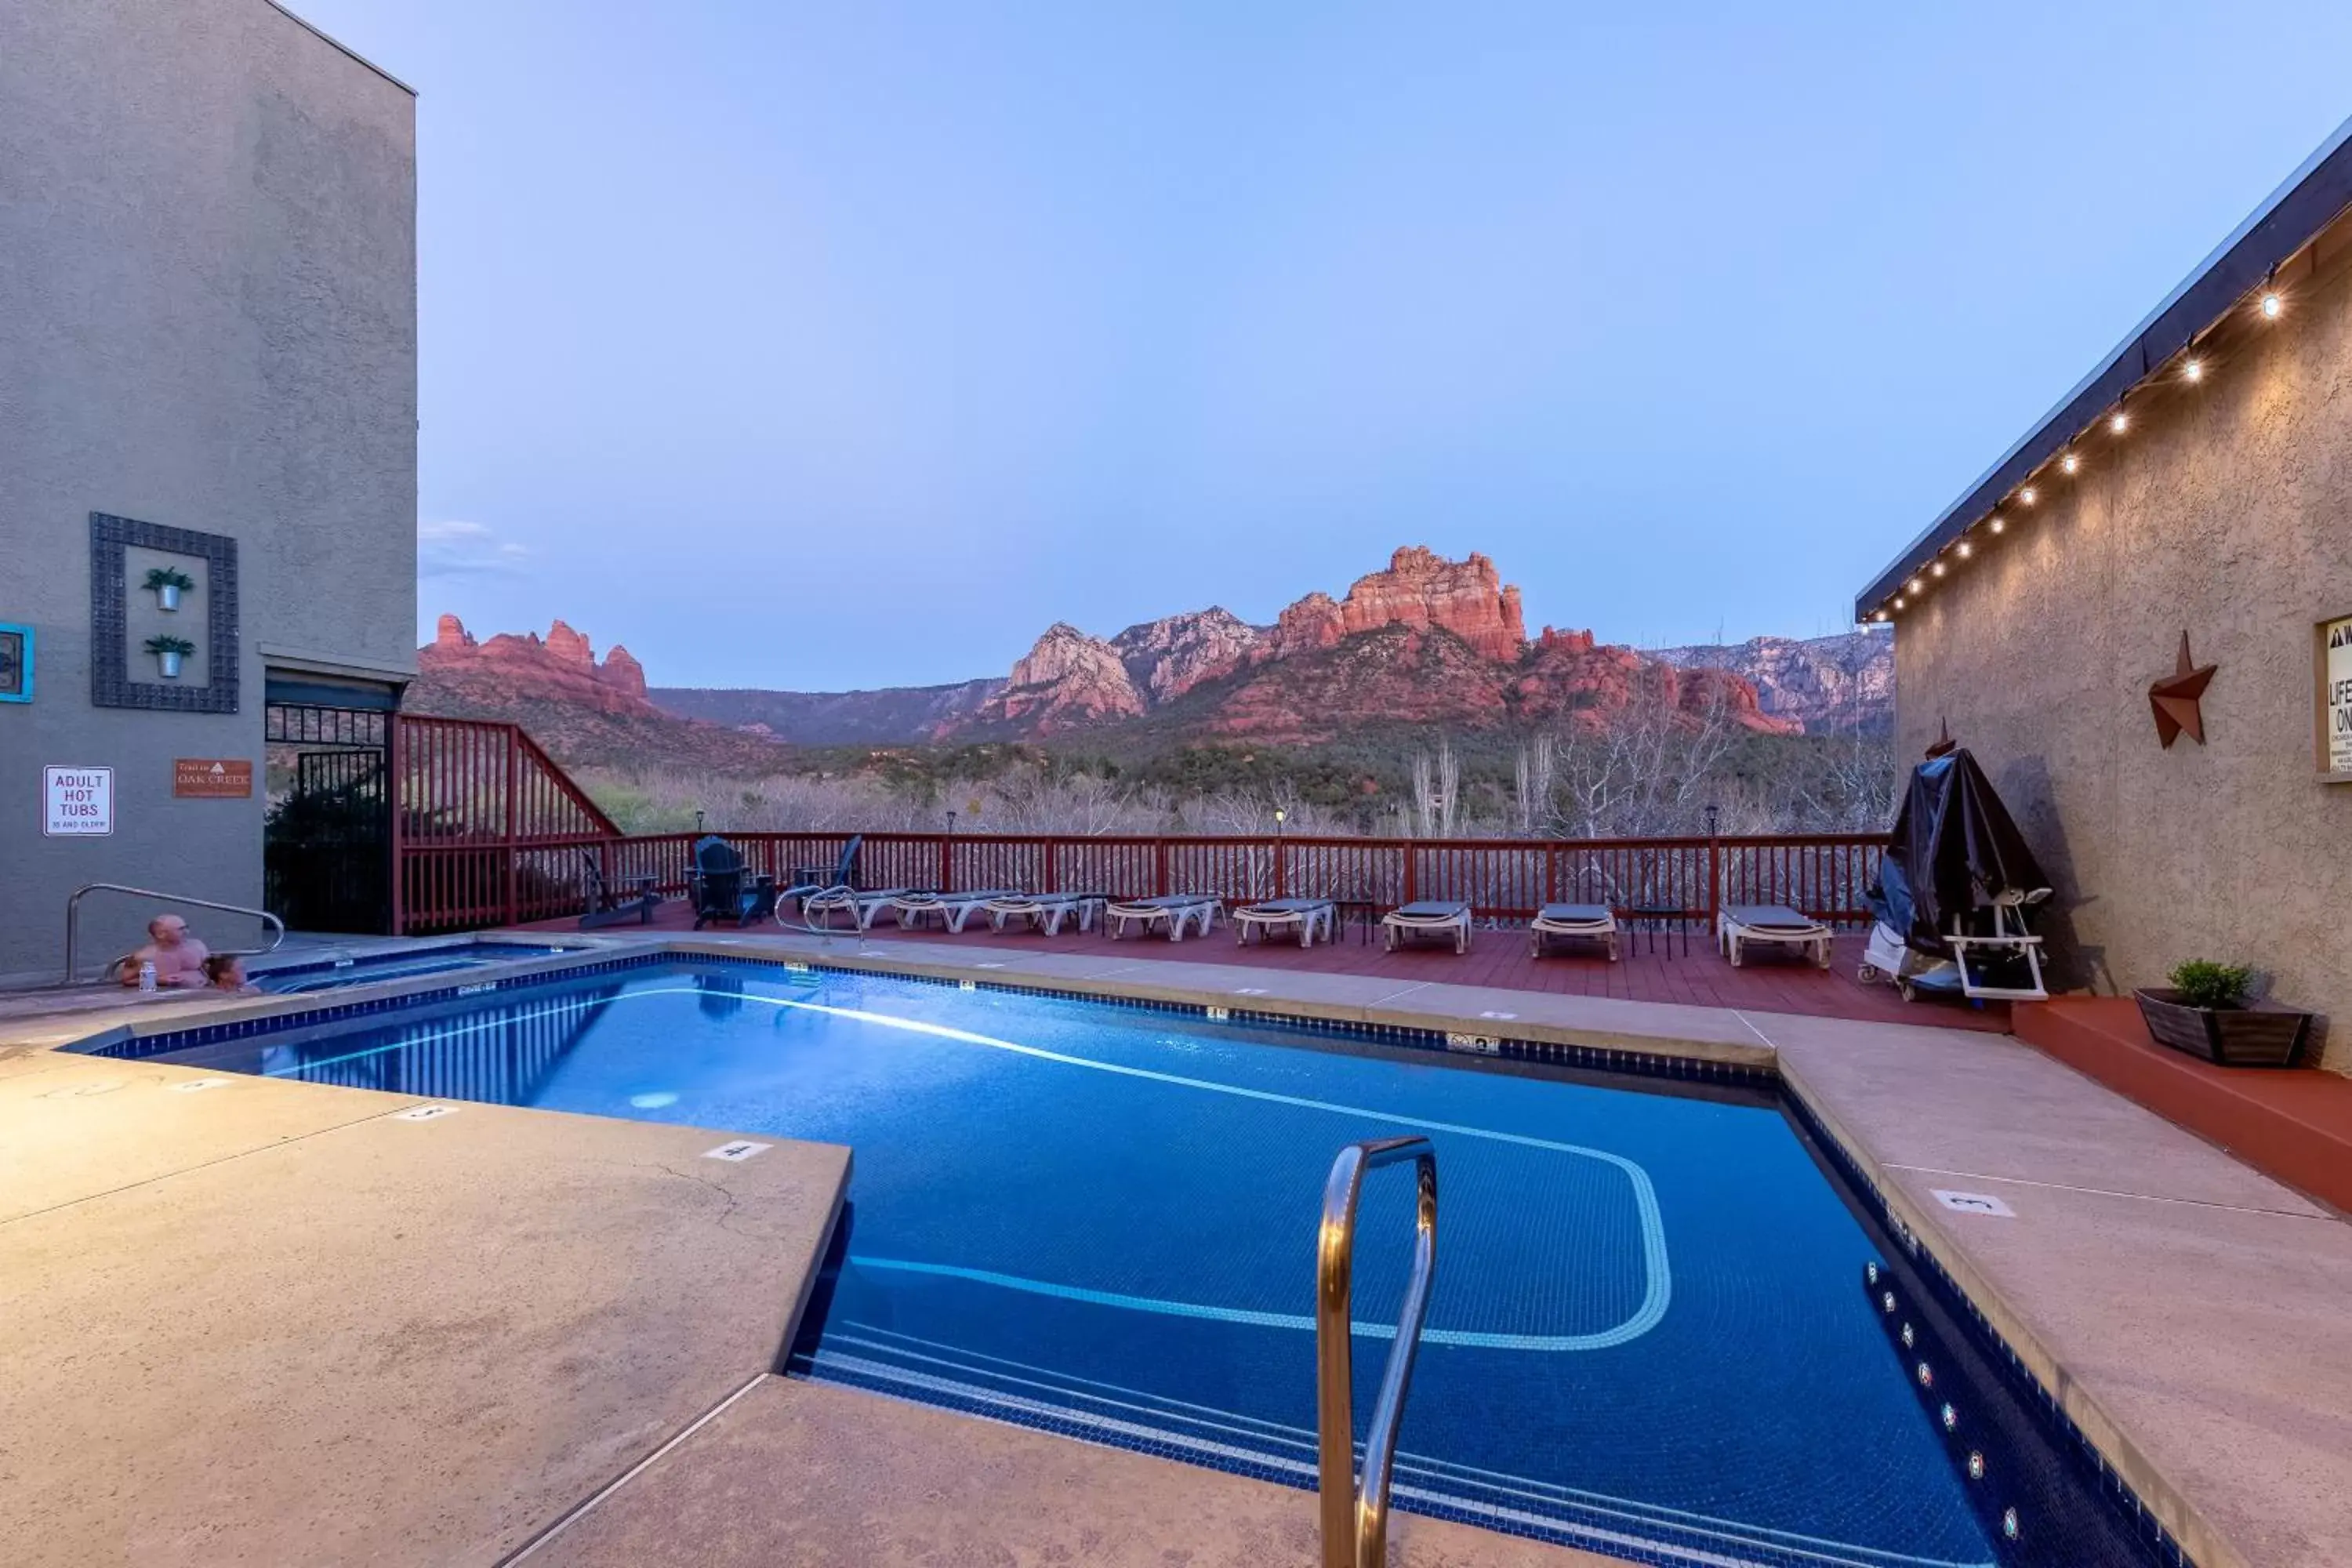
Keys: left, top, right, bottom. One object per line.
{"left": 1856, "top": 125, "right": 2352, "bottom": 1072}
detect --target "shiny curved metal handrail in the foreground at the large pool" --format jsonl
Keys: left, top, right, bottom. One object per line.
{"left": 1315, "top": 1138, "right": 1437, "bottom": 1568}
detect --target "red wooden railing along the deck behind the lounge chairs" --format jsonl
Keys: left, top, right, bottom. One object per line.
{"left": 393, "top": 715, "right": 1886, "bottom": 933}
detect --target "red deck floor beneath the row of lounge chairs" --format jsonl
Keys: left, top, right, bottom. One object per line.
{"left": 524, "top": 898, "right": 2009, "bottom": 1032}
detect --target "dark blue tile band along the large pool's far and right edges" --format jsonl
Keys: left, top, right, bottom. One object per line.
{"left": 61, "top": 945, "right": 2199, "bottom": 1568}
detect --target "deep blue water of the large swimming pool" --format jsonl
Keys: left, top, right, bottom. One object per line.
{"left": 142, "top": 961, "right": 2157, "bottom": 1568}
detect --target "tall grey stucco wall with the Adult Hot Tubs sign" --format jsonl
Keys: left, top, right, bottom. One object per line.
{"left": 0, "top": 0, "right": 416, "bottom": 975}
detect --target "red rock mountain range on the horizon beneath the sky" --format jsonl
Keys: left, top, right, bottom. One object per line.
{"left": 416, "top": 546, "right": 1816, "bottom": 746}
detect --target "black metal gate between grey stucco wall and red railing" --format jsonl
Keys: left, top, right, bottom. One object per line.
{"left": 261, "top": 703, "right": 393, "bottom": 935}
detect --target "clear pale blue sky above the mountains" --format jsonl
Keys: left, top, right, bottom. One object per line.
{"left": 296, "top": 0, "right": 2352, "bottom": 689}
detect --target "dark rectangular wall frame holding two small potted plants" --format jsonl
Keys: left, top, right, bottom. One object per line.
{"left": 89, "top": 513, "right": 240, "bottom": 713}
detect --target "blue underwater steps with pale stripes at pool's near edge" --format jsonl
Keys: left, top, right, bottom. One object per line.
{"left": 788, "top": 1321, "right": 1929, "bottom": 1568}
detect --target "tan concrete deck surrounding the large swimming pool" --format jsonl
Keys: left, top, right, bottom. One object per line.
{"left": 0, "top": 933, "right": 2352, "bottom": 1568}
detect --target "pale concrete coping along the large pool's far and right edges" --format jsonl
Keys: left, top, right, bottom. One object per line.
{"left": 18, "top": 933, "right": 2314, "bottom": 1568}
